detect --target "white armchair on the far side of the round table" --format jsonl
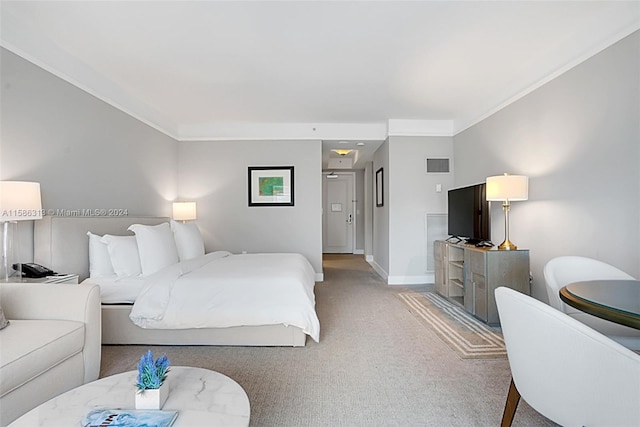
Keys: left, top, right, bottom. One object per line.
{"left": 543, "top": 256, "right": 640, "bottom": 350}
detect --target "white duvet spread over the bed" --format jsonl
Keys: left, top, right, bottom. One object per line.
{"left": 127, "top": 251, "right": 320, "bottom": 342}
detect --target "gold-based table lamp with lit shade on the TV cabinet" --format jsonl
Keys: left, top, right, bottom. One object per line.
{"left": 486, "top": 173, "right": 529, "bottom": 251}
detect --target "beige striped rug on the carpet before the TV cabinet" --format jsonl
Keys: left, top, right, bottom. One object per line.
{"left": 398, "top": 292, "right": 507, "bottom": 359}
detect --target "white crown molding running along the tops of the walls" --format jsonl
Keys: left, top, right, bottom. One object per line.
{"left": 5, "top": 3, "right": 640, "bottom": 141}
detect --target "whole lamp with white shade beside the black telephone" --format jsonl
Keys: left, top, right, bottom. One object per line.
{"left": 0, "top": 181, "right": 42, "bottom": 282}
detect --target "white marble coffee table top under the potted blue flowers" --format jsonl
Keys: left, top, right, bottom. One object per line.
{"left": 11, "top": 366, "right": 250, "bottom": 427}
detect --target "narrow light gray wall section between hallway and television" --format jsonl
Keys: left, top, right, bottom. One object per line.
{"left": 385, "top": 136, "right": 453, "bottom": 284}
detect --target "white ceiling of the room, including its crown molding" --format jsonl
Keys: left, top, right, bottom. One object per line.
{"left": 0, "top": 0, "right": 640, "bottom": 169}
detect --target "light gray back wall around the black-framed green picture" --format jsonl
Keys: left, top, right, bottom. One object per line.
{"left": 178, "top": 140, "right": 322, "bottom": 273}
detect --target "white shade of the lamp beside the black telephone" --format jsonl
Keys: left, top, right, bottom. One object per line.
{"left": 0, "top": 181, "right": 42, "bottom": 222}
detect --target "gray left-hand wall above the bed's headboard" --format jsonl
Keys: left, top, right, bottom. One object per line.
{"left": 0, "top": 49, "right": 178, "bottom": 261}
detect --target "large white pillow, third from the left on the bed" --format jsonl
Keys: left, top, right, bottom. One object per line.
{"left": 128, "top": 222, "right": 178, "bottom": 276}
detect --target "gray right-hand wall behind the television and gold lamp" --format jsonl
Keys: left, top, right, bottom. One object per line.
{"left": 454, "top": 32, "right": 640, "bottom": 301}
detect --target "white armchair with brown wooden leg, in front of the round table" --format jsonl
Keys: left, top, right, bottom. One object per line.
{"left": 495, "top": 287, "right": 640, "bottom": 426}
